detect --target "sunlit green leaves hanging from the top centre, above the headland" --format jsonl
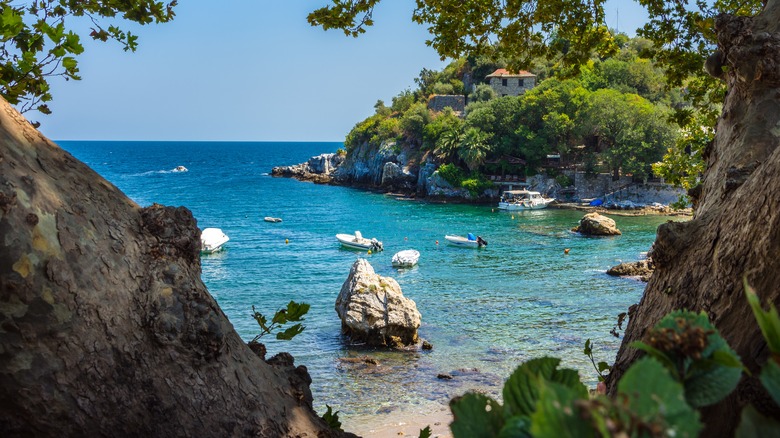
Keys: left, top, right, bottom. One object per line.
{"left": 308, "top": 0, "right": 616, "bottom": 69}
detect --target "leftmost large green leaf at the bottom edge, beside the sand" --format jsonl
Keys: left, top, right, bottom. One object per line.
{"left": 450, "top": 393, "right": 504, "bottom": 438}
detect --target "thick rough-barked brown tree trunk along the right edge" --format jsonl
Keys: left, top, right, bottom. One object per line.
{"left": 608, "top": 0, "right": 780, "bottom": 436}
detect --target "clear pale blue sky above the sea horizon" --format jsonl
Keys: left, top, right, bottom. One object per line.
{"left": 35, "top": 0, "right": 646, "bottom": 141}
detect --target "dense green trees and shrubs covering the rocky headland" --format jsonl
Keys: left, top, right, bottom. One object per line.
{"left": 345, "top": 35, "right": 706, "bottom": 188}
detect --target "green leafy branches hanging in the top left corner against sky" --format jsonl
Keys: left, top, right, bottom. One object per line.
{"left": 0, "top": 0, "right": 177, "bottom": 114}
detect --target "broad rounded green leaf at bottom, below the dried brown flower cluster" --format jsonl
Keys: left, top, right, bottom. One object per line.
{"left": 618, "top": 358, "right": 701, "bottom": 438}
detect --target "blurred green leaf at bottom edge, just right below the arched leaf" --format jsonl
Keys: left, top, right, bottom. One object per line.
{"left": 531, "top": 382, "right": 595, "bottom": 438}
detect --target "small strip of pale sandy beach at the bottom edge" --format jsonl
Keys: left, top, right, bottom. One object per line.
{"left": 342, "top": 405, "right": 452, "bottom": 438}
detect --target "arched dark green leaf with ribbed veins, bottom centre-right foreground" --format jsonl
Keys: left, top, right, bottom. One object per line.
{"left": 503, "top": 357, "right": 588, "bottom": 418}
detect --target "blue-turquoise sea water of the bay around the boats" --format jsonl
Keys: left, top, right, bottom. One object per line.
{"left": 60, "top": 141, "right": 668, "bottom": 424}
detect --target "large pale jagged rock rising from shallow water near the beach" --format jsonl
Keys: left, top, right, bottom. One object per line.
{"left": 336, "top": 259, "right": 421, "bottom": 347}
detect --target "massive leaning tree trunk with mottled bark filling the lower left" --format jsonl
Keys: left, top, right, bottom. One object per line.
{"left": 0, "top": 99, "right": 350, "bottom": 437}
